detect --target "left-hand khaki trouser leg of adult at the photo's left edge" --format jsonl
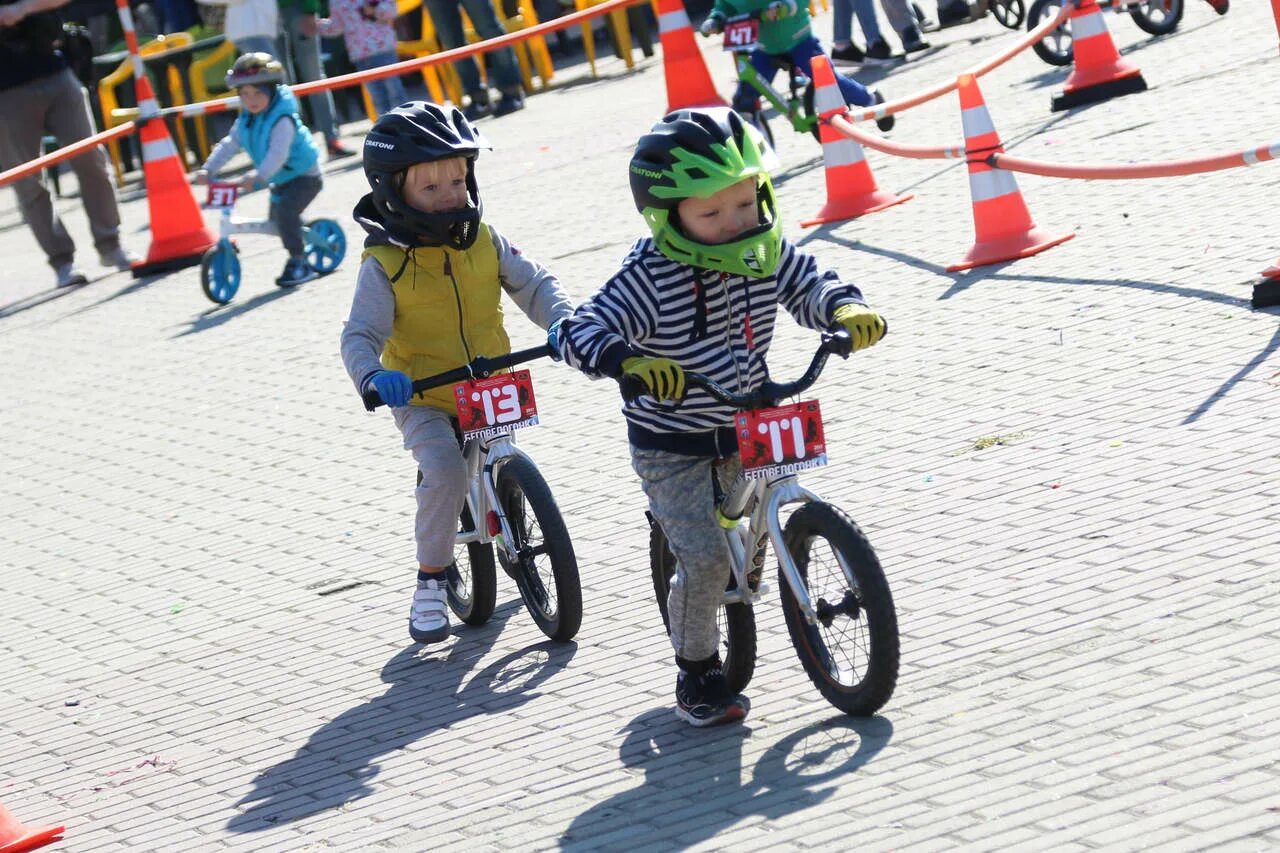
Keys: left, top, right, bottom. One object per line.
{"left": 0, "top": 72, "right": 76, "bottom": 269}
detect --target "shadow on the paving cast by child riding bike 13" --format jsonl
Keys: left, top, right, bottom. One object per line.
{"left": 227, "top": 602, "right": 577, "bottom": 833}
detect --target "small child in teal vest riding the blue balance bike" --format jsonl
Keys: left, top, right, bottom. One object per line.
{"left": 196, "top": 53, "right": 324, "bottom": 287}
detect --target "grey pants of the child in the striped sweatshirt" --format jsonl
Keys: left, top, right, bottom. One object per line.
{"left": 631, "top": 447, "right": 742, "bottom": 661}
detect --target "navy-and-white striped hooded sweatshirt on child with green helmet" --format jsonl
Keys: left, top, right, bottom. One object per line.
{"left": 559, "top": 237, "right": 863, "bottom": 457}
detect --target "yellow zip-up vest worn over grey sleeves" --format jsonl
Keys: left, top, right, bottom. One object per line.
{"left": 362, "top": 227, "right": 511, "bottom": 414}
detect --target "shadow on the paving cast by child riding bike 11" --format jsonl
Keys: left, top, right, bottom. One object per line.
{"left": 559, "top": 708, "right": 893, "bottom": 850}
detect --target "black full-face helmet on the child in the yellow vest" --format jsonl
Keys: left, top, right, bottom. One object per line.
{"left": 365, "top": 101, "right": 488, "bottom": 248}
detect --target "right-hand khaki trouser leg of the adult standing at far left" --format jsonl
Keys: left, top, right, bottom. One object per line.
{"left": 49, "top": 69, "right": 120, "bottom": 257}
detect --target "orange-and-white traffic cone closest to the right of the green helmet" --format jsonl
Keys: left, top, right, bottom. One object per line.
{"left": 800, "top": 55, "right": 911, "bottom": 228}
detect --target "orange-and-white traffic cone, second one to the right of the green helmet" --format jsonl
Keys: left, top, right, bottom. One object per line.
{"left": 947, "top": 74, "right": 1075, "bottom": 273}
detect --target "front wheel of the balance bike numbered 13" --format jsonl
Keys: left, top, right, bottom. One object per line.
{"left": 498, "top": 456, "right": 582, "bottom": 643}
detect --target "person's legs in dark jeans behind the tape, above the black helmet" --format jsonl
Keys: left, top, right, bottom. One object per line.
{"left": 424, "top": 0, "right": 525, "bottom": 120}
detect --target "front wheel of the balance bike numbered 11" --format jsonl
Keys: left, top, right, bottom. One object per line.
{"left": 778, "top": 502, "right": 899, "bottom": 716}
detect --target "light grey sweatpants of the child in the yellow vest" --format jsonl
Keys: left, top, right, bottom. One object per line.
{"left": 392, "top": 406, "right": 467, "bottom": 567}
